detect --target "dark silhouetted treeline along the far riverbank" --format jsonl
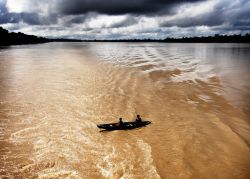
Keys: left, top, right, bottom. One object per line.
{"left": 0, "top": 27, "right": 250, "bottom": 46}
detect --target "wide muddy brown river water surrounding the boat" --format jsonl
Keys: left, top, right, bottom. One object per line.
{"left": 0, "top": 43, "right": 250, "bottom": 179}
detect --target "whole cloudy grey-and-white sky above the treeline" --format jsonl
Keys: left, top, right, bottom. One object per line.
{"left": 0, "top": 0, "right": 250, "bottom": 39}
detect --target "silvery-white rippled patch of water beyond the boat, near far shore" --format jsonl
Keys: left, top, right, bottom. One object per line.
{"left": 91, "top": 44, "right": 216, "bottom": 85}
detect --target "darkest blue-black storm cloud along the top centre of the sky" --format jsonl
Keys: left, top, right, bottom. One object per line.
{"left": 57, "top": 0, "right": 203, "bottom": 15}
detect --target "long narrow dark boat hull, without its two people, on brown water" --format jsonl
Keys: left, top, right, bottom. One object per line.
{"left": 97, "top": 121, "right": 151, "bottom": 131}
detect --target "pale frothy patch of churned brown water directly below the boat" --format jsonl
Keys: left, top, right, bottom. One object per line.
{"left": 96, "top": 139, "right": 160, "bottom": 178}
